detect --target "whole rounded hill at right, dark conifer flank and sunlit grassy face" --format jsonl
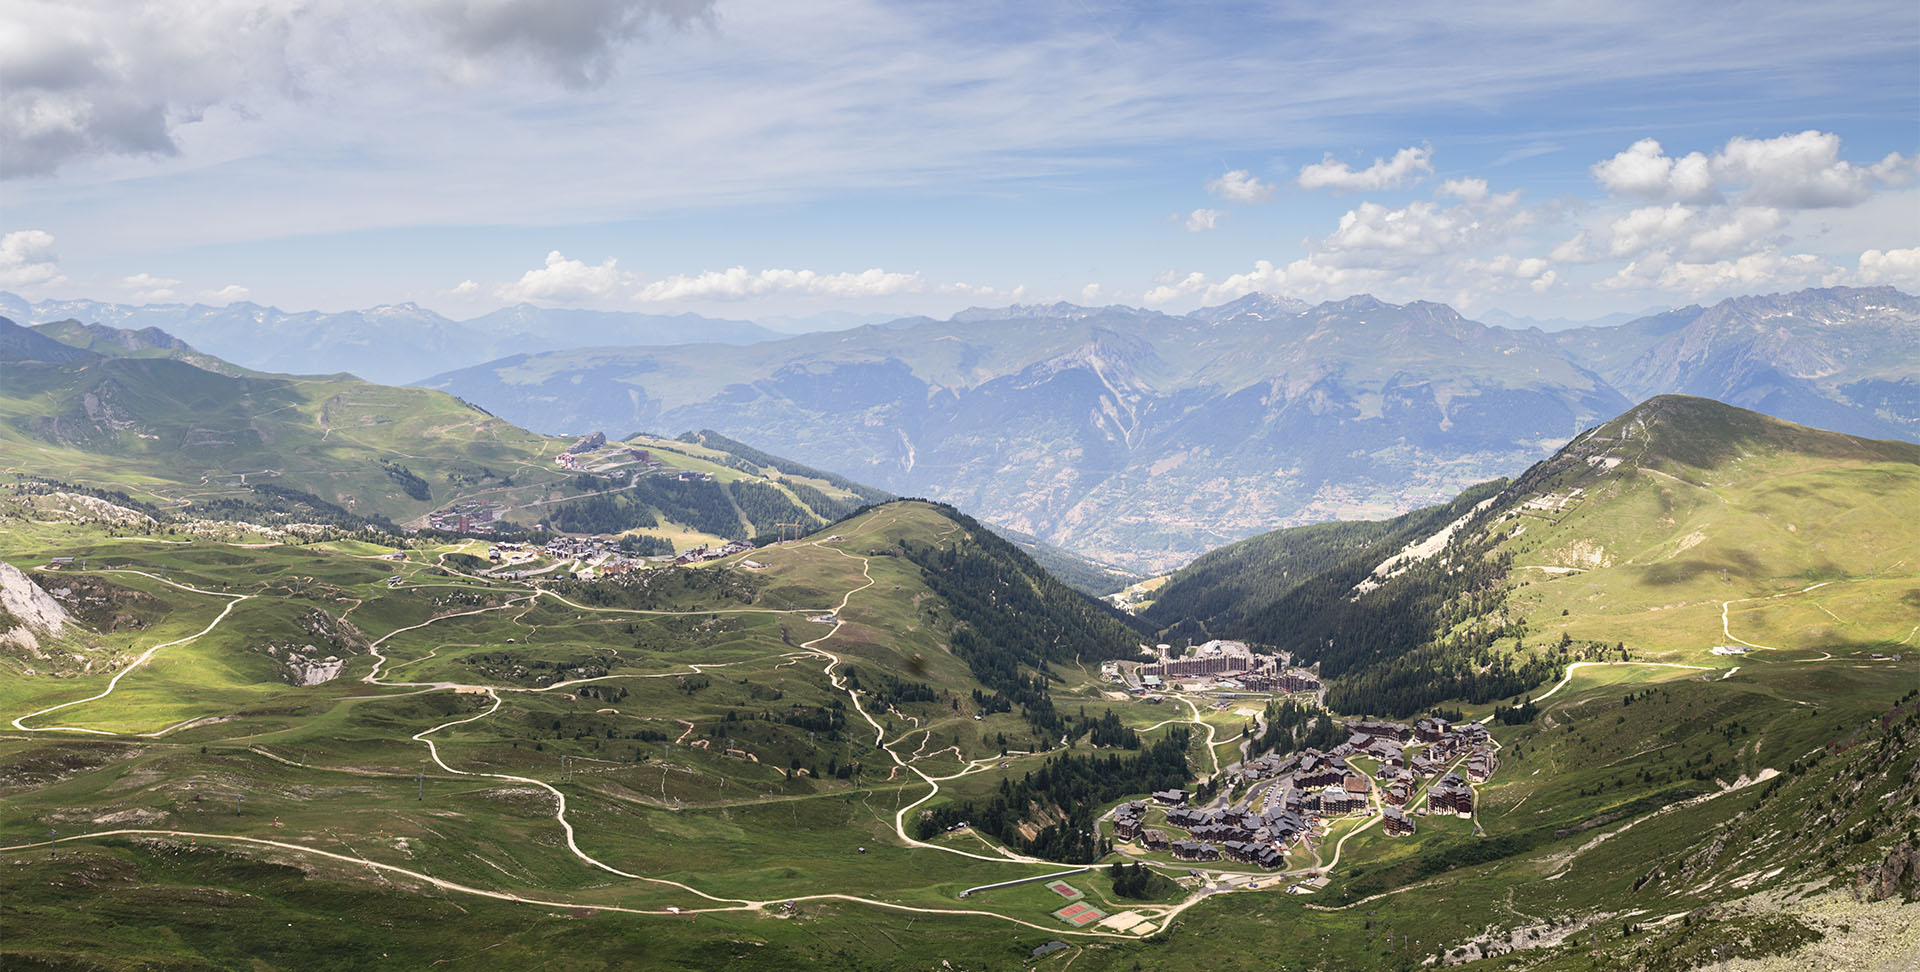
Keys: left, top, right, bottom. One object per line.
{"left": 1144, "top": 396, "right": 1920, "bottom": 715}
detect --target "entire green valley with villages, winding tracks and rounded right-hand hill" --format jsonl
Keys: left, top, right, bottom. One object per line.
{"left": 0, "top": 320, "right": 1920, "bottom": 970}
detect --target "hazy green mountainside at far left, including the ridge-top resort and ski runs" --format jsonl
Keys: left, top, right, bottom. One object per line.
{"left": 0, "top": 321, "right": 887, "bottom": 547}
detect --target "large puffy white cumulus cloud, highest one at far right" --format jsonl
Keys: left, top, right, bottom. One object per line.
{"left": 1592, "top": 131, "right": 1916, "bottom": 209}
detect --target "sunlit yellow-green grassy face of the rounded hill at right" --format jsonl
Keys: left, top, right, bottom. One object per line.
{"left": 1488, "top": 396, "right": 1920, "bottom": 663}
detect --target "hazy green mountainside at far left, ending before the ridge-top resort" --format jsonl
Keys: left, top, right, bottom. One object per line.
{"left": 0, "top": 322, "right": 563, "bottom": 519}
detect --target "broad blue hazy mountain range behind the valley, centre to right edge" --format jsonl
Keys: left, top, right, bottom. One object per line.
{"left": 422, "top": 288, "right": 1920, "bottom": 571}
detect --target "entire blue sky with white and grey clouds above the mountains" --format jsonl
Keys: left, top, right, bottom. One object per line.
{"left": 0, "top": 0, "right": 1920, "bottom": 317}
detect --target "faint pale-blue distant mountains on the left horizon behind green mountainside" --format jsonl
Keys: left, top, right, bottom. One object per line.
{"left": 0, "top": 292, "right": 780, "bottom": 384}
